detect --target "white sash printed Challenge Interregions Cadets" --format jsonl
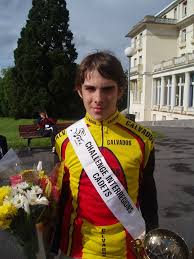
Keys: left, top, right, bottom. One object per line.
{"left": 66, "top": 119, "right": 145, "bottom": 239}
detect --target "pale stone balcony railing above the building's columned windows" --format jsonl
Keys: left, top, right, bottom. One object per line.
{"left": 153, "top": 53, "right": 194, "bottom": 72}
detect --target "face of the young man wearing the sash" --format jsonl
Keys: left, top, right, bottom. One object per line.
{"left": 78, "top": 70, "right": 122, "bottom": 121}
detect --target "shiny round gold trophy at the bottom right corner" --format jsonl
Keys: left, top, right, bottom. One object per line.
{"left": 133, "top": 228, "right": 189, "bottom": 259}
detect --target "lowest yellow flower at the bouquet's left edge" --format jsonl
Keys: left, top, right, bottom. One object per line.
{"left": 0, "top": 203, "right": 17, "bottom": 229}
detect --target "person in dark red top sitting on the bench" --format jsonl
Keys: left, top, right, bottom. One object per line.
{"left": 37, "top": 111, "right": 58, "bottom": 153}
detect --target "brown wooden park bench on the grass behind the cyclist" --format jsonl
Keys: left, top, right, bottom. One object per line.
{"left": 19, "top": 121, "right": 75, "bottom": 150}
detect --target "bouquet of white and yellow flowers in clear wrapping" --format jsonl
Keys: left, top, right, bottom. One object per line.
{"left": 0, "top": 152, "right": 49, "bottom": 259}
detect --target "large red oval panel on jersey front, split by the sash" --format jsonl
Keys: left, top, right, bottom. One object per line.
{"left": 77, "top": 148, "right": 127, "bottom": 226}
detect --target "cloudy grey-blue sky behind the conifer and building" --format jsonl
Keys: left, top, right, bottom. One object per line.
{"left": 0, "top": 0, "right": 172, "bottom": 69}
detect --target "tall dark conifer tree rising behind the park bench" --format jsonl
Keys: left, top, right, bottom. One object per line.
{"left": 13, "top": 0, "right": 82, "bottom": 118}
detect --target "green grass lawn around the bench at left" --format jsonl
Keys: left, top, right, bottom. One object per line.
{"left": 0, "top": 117, "right": 51, "bottom": 149}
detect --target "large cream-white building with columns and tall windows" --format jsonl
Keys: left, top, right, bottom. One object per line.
{"left": 127, "top": 0, "right": 194, "bottom": 121}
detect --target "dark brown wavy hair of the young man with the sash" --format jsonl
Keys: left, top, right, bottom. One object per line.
{"left": 75, "top": 51, "right": 127, "bottom": 90}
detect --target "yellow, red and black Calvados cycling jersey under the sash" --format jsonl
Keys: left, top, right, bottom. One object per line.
{"left": 53, "top": 112, "right": 158, "bottom": 259}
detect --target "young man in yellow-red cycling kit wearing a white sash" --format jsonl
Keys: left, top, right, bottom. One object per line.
{"left": 46, "top": 52, "right": 158, "bottom": 259}
